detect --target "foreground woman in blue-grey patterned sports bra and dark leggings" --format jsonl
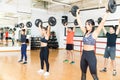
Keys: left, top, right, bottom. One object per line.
{"left": 76, "top": 10, "right": 109, "bottom": 80}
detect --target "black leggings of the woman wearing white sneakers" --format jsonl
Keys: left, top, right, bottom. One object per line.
{"left": 40, "top": 47, "right": 49, "bottom": 72}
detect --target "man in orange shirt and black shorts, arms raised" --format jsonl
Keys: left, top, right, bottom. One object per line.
{"left": 63, "top": 22, "right": 75, "bottom": 64}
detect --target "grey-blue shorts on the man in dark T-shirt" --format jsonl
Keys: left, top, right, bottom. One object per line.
{"left": 104, "top": 47, "right": 116, "bottom": 60}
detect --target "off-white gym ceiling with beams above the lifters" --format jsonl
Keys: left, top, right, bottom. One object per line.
{"left": 32, "top": 0, "right": 120, "bottom": 11}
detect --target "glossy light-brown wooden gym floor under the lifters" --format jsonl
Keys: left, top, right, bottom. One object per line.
{"left": 0, "top": 49, "right": 120, "bottom": 80}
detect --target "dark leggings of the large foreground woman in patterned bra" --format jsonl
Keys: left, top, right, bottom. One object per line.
{"left": 81, "top": 50, "right": 98, "bottom": 80}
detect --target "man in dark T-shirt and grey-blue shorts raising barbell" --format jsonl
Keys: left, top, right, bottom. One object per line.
{"left": 100, "top": 20, "right": 120, "bottom": 76}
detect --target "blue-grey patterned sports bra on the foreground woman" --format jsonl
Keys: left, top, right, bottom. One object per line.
{"left": 83, "top": 33, "right": 96, "bottom": 45}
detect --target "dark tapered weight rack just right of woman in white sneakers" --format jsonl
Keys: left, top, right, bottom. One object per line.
{"left": 48, "top": 31, "right": 59, "bottom": 49}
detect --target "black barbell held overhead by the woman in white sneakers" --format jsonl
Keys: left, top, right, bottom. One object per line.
{"left": 35, "top": 16, "right": 57, "bottom": 27}
